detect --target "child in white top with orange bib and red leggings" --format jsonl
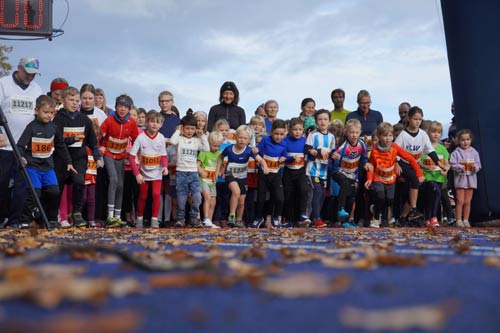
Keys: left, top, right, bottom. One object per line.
{"left": 129, "top": 111, "right": 168, "bottom": 228}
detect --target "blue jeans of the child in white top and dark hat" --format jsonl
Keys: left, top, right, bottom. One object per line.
{"left": 175, "top": 171, "right": 201, "bottom": 221}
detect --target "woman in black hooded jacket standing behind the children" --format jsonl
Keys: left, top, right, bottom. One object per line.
{"left": 208, "top": 81, "right": 246, "bottom": 131}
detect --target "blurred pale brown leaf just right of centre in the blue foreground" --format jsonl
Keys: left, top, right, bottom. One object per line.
{"left": 258, "top": 272, "right": 351, "bottom": 298}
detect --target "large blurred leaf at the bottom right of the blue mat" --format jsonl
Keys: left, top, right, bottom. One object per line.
{"left": 338, "top": 300, "right": 460, "bottom": 331}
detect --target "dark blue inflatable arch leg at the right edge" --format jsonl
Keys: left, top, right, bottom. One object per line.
{"left": 441, "top": 0, "right": 500, "bottom": 221}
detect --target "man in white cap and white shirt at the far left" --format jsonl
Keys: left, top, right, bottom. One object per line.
{"left": 0, "top": 57, "right": 43, "bottom": 227}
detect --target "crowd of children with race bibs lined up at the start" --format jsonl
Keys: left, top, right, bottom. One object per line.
{"left": 12, "top": 85, "right": 481, "bottom": 228}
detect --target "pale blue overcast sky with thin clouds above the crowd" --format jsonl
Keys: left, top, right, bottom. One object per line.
{"left": 0, "top": 0, "right": 452, "bottom": 128}
